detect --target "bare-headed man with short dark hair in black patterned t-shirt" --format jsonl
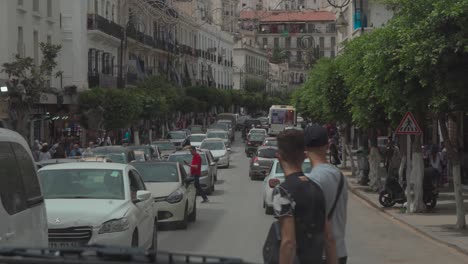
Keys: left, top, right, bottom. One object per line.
{"left": 264, "top": 129, "right": 337, "bottom": 264}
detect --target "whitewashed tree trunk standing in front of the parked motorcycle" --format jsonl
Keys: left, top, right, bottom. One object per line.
{"left": 407, "top": 136, "right": 425, "bottom": 213}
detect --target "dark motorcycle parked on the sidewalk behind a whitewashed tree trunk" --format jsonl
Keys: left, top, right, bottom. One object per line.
{"left": 379, "top": 168, "right": 439, "bottom": 209}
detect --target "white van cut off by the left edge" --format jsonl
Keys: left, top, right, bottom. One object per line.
{"left": 0, "top": 128, "right": 48, "bottom": 248}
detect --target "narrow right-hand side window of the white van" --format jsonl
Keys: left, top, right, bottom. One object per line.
{"left": 11, "top": 143, "right": 43, "bottom": 206}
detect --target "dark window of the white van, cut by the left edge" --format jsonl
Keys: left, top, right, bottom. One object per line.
{"left": 0, "top": 142, "right": 30, "bottom": 215}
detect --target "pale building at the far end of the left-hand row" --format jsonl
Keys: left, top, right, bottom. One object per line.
{"left": 233, "top": 41, "right": 269, "bottom": 90}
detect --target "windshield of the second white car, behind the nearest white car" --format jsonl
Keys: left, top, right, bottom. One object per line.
{"left": 133, "top": 163, "right": 179, "bottom": 182}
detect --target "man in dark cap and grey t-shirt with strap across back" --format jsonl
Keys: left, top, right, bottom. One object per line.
{"left": 304, "top": 125, "right": 348, "bottom": 264}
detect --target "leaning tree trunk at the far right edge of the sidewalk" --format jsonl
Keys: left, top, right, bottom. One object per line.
{"left": 439, "top": 114, "right": 466, "bottom": 229}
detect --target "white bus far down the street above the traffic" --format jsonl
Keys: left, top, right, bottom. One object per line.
{"left": 268, "top": 105, "right": 297, "bottom": 135}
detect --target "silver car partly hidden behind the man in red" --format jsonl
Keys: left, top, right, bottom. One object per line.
{"left": 168, "top": 150, "right": 218, "bottom": 194}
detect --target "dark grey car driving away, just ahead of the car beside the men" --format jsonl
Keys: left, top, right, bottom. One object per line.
{"left": 249, "top": 147, "right": 278, "bottom": 180}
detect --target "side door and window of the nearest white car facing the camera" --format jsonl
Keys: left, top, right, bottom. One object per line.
{"left": 128, "top": 169, "right": 154, "bottom": 245}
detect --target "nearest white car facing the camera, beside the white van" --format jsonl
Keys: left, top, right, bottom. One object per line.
{"left": 39, "top": 162, "right": 157, "bottom": 249}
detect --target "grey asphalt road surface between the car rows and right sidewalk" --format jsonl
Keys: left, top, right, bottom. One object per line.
{"left": 159, "top": 136, "right": 467, "bottom": 264}
